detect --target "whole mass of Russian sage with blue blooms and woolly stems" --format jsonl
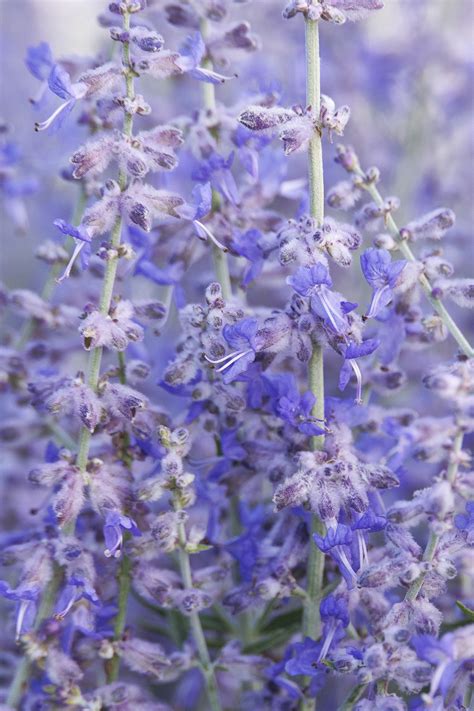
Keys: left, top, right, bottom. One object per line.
{"left": 0, "top": 0, "right": 474, "bottom": 711}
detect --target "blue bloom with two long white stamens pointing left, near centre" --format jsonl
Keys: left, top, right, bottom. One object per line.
{"left": 206, "top": 318, "right": 258, "bottom": 383}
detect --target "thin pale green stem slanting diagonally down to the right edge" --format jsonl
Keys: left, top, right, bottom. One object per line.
{"left": 355, "top": 178, "right": 474, "bottom": 358}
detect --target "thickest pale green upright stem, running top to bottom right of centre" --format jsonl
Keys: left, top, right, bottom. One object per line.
{"left": 301, "top": 19, "right": 324, "bottom": 711}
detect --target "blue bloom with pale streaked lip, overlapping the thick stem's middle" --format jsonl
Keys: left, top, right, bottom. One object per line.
{"left": 287, "top": 263, "right": 357, "bottom": 335}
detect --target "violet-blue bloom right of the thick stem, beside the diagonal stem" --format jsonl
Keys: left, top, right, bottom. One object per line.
{"left": 360, "top": 247, "right": 406, "bottom": 318}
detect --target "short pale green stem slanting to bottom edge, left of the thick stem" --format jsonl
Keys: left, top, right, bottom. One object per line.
{"left": 178, "top": 523, "right": 221, "bottom": 711}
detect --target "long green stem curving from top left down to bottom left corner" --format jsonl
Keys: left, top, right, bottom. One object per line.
{"left": 8, "top": 13, "right": 135, "bottom": 708}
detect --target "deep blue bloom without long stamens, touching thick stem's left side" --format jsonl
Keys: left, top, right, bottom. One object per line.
{"left": 263, "top": 373, "right": 324, "bottom": 436}
